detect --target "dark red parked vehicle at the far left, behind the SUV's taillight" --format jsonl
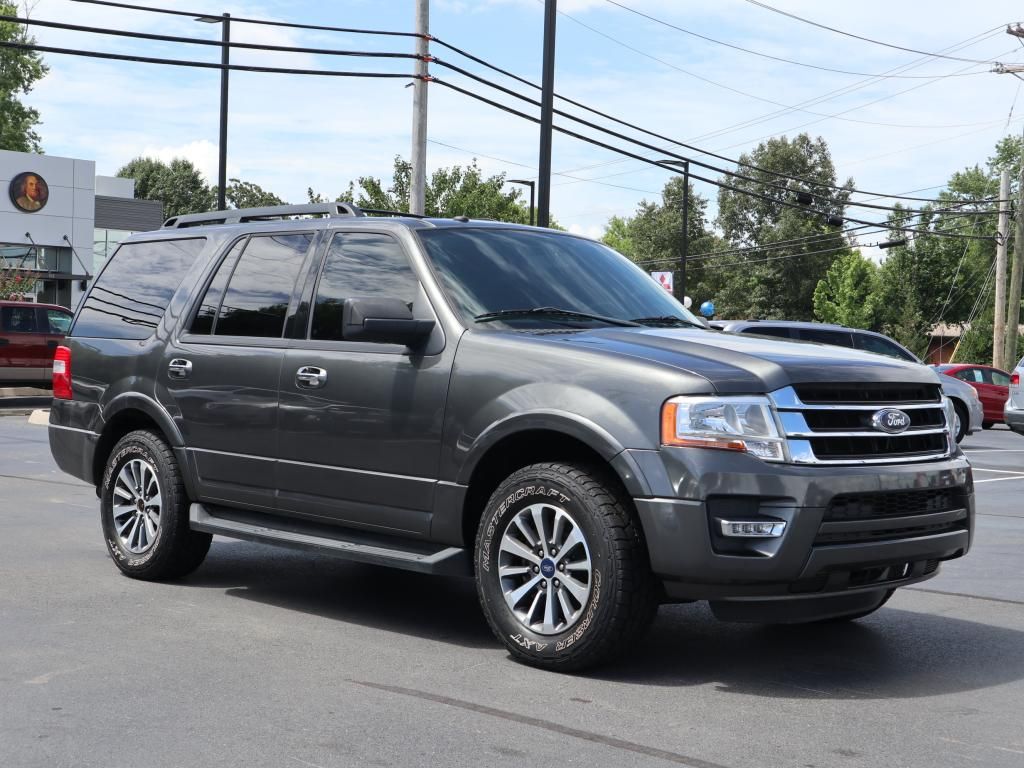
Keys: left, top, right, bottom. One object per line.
{"left": 0, "top": 301, "right": 73, "bottom": 384}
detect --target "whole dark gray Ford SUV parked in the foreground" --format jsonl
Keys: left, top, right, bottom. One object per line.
{"left": 49, "top": 204, "right": 974, "bottom": 670}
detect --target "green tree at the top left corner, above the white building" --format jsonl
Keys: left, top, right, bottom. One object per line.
{"left": 0, "top": 2, "right": 49, "bottom": 153}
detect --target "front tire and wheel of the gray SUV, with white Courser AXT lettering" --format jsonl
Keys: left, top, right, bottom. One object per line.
{"left": 475, "top": 463, "right": 658, "bottom": 672}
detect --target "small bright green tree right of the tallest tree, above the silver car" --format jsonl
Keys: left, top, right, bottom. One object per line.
{"left": 814, "top": 251, "right": 879, "bottom": 331}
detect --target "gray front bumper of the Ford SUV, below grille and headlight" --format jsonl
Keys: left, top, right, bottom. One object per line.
{"left": 631, "top": 449, "right": 974, "bottom": 600}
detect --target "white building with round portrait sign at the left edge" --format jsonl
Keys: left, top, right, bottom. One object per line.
{"left": 0, "top": 150, "right": 163, "bottom": 308}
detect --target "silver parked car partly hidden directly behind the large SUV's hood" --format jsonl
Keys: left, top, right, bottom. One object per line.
{"left": 711, "top": 321, "right": 985, "bottom": 442}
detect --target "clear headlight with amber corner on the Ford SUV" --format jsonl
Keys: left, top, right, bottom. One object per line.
{"left": 662, "top": 397, "right": 785, "bottom": 462}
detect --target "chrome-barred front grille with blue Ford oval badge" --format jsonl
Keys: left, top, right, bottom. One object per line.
{"left": 772, "top": 383, "right": 953, "bottom": 464}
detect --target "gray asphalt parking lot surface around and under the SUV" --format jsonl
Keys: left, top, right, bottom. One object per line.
{"left": 0, "top": 414, "right": 1024, "bottom": 768}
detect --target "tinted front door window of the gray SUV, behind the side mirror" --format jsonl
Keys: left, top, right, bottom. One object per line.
{"left": 311, "top": 232, "right": 420, "bottom": 340}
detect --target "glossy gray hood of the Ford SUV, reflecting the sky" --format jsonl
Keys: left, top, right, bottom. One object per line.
{"left": 547, "top": 328, "right": 939, "bottom": 394}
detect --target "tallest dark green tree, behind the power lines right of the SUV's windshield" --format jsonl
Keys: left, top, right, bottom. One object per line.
{"left": 716, "top": 133, "right": 853, "bottom": 319}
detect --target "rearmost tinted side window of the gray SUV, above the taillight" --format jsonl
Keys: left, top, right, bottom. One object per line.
{"left": 74, "top": 238, "right": 206, "bottom": 339}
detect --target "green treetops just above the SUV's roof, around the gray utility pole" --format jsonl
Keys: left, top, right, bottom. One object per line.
{"left": 337, "top": 156, "right": 544, "bottom": 228}
